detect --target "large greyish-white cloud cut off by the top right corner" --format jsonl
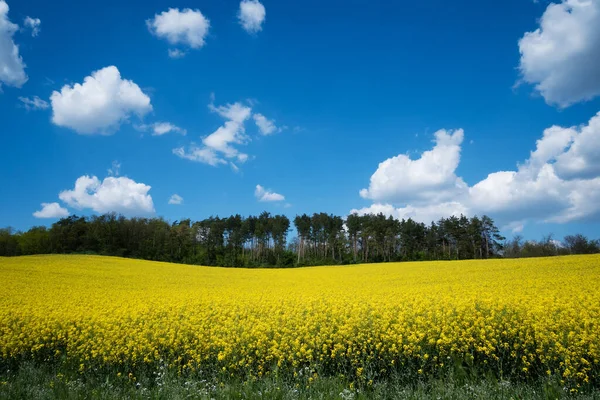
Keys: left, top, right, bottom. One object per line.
{"left": 519, "top": 0, "right": 600, "bottom": 107}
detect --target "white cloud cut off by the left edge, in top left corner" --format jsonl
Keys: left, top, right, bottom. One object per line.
{"left": 0, "top": 0, "right": 28, "bottom": 88}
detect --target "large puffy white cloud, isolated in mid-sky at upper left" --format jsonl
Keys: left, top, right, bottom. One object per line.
{"left": 50, "top": 66, "right": 152, "bottom": 135}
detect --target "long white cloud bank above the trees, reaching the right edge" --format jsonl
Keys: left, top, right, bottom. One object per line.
{"left": 351, "top": 113, "right": 600, "bottom": 231}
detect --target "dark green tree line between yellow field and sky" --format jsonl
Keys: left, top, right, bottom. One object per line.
{"left": 0, "top": 212, "right": 600, "bottom": 267}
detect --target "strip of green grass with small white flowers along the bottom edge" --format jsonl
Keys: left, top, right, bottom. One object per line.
{"left": 0, "top": 362, "right": 600, "bottom": 400}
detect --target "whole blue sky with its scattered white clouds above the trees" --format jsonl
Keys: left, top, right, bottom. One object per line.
{"left": 0, "top": 0, "right": 600, "bottom": 238}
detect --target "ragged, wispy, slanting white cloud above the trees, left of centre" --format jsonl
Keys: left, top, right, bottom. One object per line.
{"left": 173, "top": 103, "right": 252, "bottom": 170}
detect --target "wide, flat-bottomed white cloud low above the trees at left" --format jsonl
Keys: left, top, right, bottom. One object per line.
{"left": 58, "top": 175, "right": 154, "bottom": 215}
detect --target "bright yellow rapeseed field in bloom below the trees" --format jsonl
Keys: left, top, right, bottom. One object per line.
{"left": 0, "top": 256, "right": 600, "bottom": 387}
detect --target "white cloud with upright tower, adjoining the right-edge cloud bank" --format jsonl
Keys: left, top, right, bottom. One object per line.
{"left": 360, "top": 129, "right": 466, "bottom": 203}
